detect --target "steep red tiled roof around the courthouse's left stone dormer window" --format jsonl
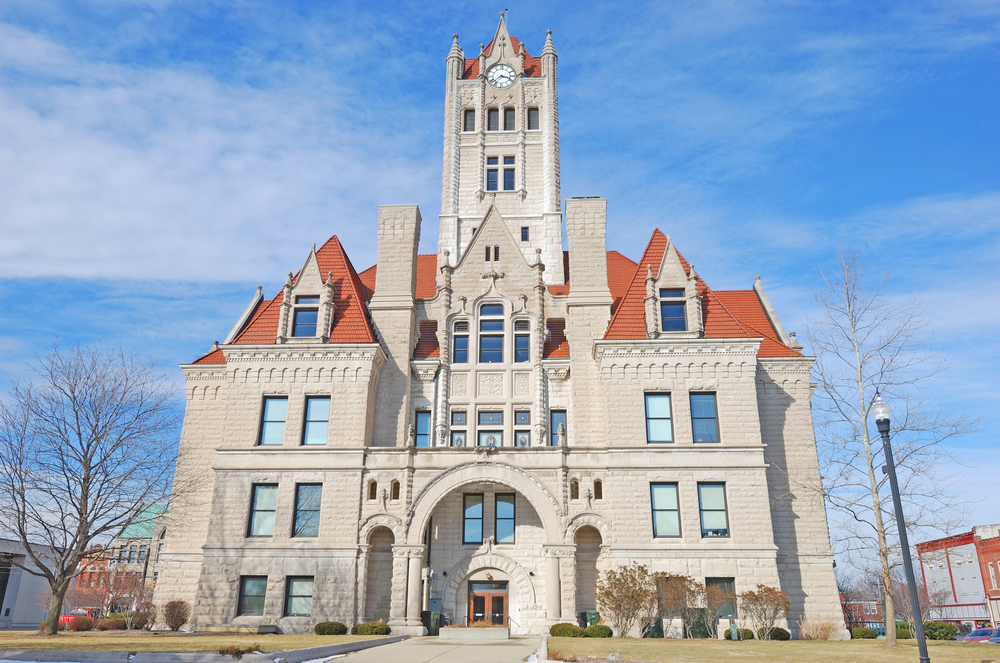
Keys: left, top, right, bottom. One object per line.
{"left": 225, "top": 235, "right": 375, "bottom": 352}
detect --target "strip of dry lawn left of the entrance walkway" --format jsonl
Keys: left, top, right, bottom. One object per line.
{"left": 0, "top": 631, "right": 379, "bottom": 652}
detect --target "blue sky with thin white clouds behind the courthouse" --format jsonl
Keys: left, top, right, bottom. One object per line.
{"left": 0, "top": 0, "right": 1000, "bottom": 540}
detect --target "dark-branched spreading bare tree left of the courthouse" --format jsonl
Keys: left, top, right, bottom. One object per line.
{"left": 0, "top": 345, "right": 178, "bottom": 634}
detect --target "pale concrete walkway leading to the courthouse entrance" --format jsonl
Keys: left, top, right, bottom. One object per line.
{"left": 344, "top": 636, "right": 541, "bottom": 663}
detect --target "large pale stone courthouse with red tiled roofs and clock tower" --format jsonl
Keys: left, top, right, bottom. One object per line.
{"left": 156, "top": 20, "right": 843, "bottom": 633}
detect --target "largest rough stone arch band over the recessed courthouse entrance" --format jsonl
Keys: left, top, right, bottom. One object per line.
{"left": 406, "top": 461, "right": 563, "bottom": 546}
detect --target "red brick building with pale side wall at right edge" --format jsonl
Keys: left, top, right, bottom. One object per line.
{"left": 916, "top": 525, "right": 1000, "bottom": 629}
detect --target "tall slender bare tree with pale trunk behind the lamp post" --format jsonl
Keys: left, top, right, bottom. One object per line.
{"left": 807, "top": 250, "right": 979, "bottom": 646}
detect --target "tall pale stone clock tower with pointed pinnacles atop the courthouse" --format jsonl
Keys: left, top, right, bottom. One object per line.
{"left": 438, "top": 14, "right": 565, "bottom": 285}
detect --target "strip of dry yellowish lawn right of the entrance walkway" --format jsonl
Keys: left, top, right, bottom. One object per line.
{"left": 549, "top": 638, "right": 1000, "bottom": 663}
